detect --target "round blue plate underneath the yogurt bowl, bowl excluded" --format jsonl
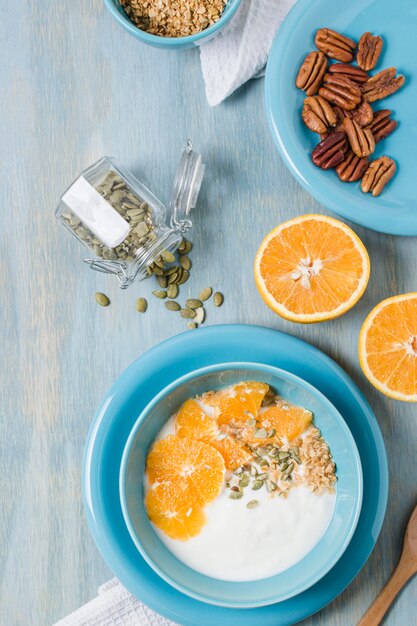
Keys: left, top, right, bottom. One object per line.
{"left": 83, "top": 324, "right": 388, "bottom": 626}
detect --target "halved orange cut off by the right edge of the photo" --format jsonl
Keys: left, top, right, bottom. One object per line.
{"left": 359, "top": 293, "right": 417, "bottom": 402}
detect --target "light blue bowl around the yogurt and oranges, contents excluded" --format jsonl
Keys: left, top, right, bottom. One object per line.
{"left": 120, "top": 363, "right": 363, "bottom": 608}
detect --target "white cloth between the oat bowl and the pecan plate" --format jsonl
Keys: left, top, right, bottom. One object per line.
{"left": 200, "top": 0, "right": 295, "bottom": 106}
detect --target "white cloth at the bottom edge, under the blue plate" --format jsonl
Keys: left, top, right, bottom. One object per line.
{"left": 55, "top": 578, "right": 176, "bottom": 626}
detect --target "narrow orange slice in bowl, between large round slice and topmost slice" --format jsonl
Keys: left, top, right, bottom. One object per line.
{"left": 175, "top": 399, "right": 251, "bottom": 470}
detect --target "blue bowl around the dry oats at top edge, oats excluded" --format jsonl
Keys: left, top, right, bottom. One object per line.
{"left": 104, "top": 0, "right": 240, "bottom": 50}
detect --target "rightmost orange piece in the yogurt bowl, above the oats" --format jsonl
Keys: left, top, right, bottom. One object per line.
{"left": 261, "top": 403, "right": 313, "bottom": 441}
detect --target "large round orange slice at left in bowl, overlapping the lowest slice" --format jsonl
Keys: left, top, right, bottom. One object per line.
{"left": 146, "top": 435, "right": 225, "bottom": 504}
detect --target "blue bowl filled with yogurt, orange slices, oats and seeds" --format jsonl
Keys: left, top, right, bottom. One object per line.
{"left": 119, "top": 363, "right": 362, "bottom": 608}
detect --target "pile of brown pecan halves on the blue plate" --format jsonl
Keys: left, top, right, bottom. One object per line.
{"left": 296, "top": 28, "right": 405, "bottom": 196}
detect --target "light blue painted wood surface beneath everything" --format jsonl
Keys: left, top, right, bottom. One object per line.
{"left": 0, "top": 0, "right": 417, "bottom": 626}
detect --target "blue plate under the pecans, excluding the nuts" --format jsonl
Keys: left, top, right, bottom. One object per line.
{"left": 265, "top": 0, "right": 417, "bottom": 235}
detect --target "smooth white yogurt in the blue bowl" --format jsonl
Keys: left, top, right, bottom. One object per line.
{"left": 146, "top": 417, "right": 336, "bottom": 582}
